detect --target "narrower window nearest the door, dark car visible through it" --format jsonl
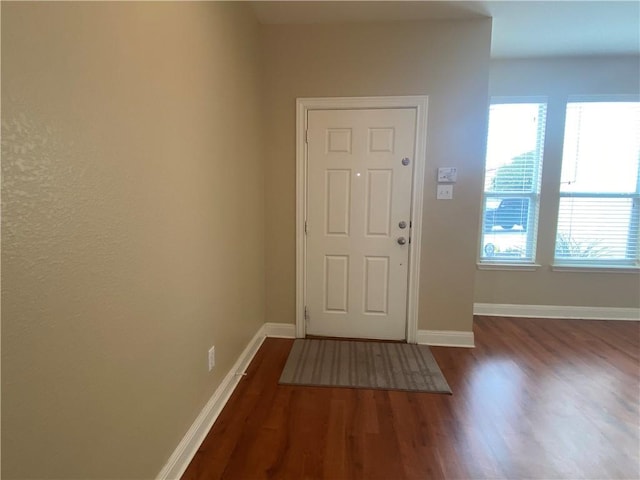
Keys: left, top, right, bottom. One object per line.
{"left": 480, "top": 99, "right": 547, "bottom": 264}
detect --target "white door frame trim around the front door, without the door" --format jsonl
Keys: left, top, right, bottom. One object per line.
{"left": 296, "top": 95, "right": 429, "bottom": 343}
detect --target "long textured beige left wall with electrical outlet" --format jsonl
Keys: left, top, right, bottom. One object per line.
{"left": 2, "top": 2, "right": 264, "bottom": 479}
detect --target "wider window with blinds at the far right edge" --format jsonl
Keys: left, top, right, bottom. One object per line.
{"left": 555, "top": 98, "right": 640, "bottom": 266}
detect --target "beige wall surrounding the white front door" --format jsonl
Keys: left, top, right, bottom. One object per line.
{"left": 262, "top": 19, "right": 491, "bottom": 331}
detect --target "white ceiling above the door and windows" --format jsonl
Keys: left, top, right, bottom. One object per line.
{"left": 252, "top": 0, "right": 640, "bottom": 58}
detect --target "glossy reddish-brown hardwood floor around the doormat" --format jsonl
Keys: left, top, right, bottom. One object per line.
{"left": 183, "top": 317, "right": 640, "bottom": 480}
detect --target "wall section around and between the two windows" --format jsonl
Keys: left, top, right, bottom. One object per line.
{"left": 475, "top": 57, "right": 640, "bottom": 308}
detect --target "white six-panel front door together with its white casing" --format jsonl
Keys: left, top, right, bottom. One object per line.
{"left": 296, "top": 97, "right": 427, "bottom": 343}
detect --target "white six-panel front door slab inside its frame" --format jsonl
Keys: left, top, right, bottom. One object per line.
{"left": 306, "top": 108, "right": 416, "bottom": 340}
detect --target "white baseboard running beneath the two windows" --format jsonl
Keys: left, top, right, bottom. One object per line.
{"left": 473, "top": 303, "right": 640, "bottom": 321}
